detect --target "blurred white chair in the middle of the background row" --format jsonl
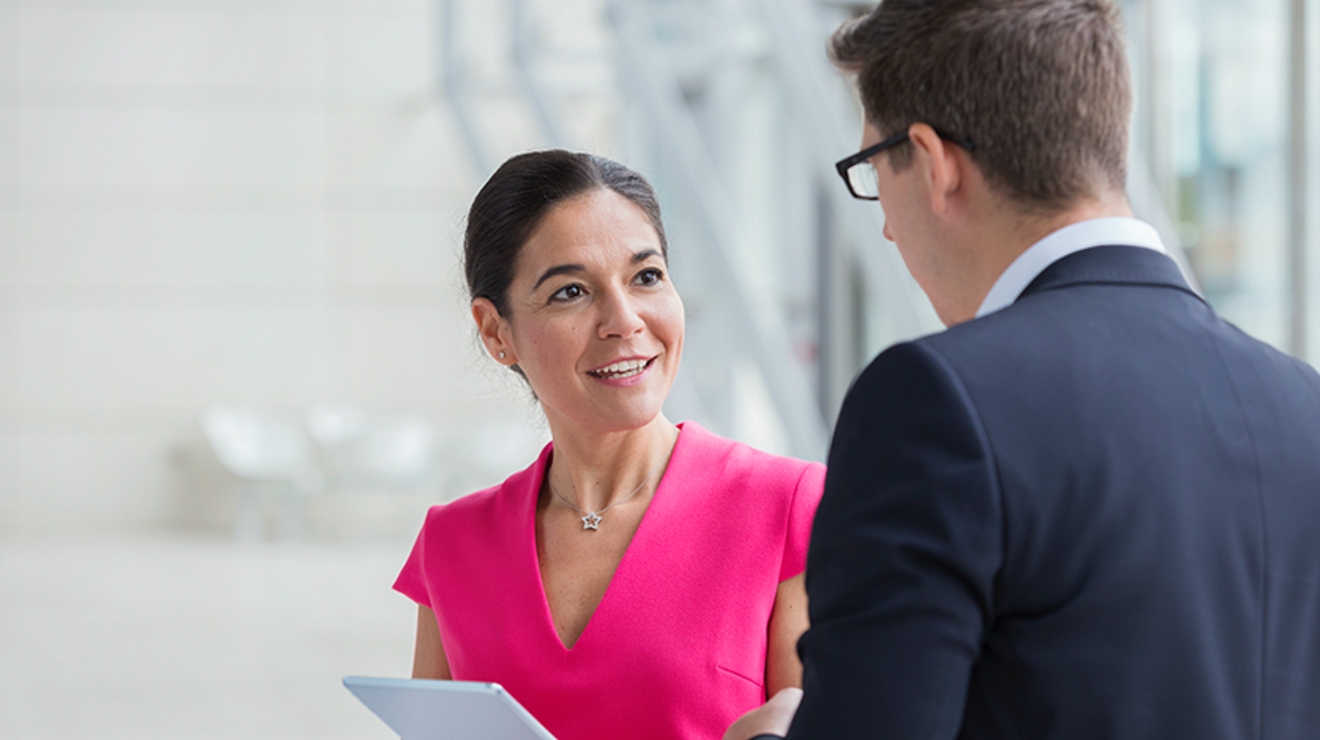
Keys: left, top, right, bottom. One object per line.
{"left": 308, "top": 405, "right": 440, "bottom": 491}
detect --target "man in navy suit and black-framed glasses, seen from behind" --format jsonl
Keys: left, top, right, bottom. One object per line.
{"left": 727, "top": 0, "right": 1320, "bottom": 740}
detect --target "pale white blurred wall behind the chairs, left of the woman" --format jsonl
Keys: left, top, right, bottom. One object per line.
{"left": 0, "top": 0, "right": 551, "bottom": 536}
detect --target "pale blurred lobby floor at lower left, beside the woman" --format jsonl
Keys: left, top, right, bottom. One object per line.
{"left": 0, "top": 536, "right": 416, "bottom": 740}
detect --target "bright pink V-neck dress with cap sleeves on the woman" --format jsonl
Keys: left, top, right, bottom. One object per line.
{"left": 395, "top": 422, "right": 825, "bottom": 740}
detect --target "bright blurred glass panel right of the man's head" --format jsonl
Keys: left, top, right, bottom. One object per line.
{"left": 1125, "top": 0, "right": 1290, "bottom": 348}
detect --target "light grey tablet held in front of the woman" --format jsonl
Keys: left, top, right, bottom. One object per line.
{"left": 343, "top": 675, "right": 554, "bottom": 740}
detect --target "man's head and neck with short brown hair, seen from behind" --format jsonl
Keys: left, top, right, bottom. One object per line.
{"left": 830, "top": 0, "right": 1133, "bottom": 323}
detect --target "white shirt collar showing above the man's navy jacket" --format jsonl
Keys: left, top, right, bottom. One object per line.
{"left": 977, "top": 216, "right": 1167, "bottom": 318}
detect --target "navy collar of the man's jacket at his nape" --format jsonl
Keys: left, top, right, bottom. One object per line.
{"left": 1018, "top": 245, "right": 1201, "bottom": 301}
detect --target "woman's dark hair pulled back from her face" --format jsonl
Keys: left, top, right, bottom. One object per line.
{"left": 463, "top": 149, "right": 669, "bottom": 315}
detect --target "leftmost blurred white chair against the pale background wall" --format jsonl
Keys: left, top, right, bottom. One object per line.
{"left": 202, "top": 406, "right": 325, "bottom": 542}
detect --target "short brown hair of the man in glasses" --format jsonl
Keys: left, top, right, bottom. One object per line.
{"left": 830, "top": 0, "right": 1133, "bottom": 210}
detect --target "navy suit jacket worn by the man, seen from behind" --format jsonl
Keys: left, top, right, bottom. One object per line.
{"left": 789, "top": 247, "right": 1320, "bottom": 740}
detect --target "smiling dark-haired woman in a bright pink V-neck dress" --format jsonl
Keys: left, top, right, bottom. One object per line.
{"left": 395, "top": 150, "right": 825, "bottom": 740}
